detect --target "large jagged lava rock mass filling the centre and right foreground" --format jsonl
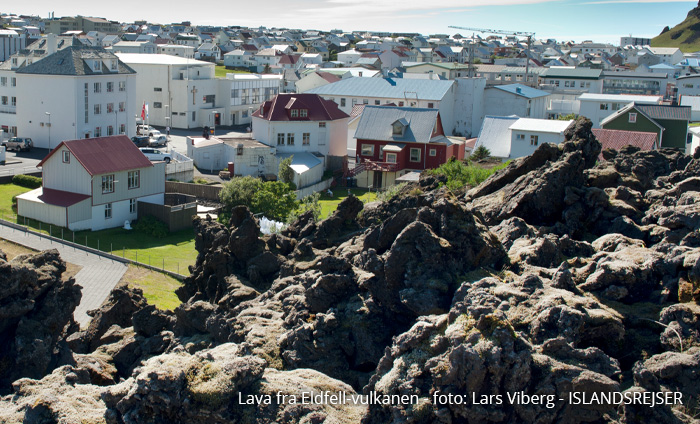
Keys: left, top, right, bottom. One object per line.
{"left": 0, "top": 119, "right": 700, "bottom": 424}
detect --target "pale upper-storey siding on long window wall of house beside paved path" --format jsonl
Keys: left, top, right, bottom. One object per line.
{"left": 92, "top": 162, "right": 165, "bottom": 206}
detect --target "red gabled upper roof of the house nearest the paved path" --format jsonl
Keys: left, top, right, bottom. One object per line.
{"left": 37, "top": 135, "right": 153, "bottom": 175}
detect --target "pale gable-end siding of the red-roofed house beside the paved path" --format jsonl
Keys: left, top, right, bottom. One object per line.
{"left": 42, "top": 147, "right": 90, "bottom": 195}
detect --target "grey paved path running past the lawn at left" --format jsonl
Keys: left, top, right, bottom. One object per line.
{"left": 0, "top": 224, "right": 127, "bottom": 327}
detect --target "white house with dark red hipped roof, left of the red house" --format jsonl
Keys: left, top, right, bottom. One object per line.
{"left": 253, "top": 94, "right": 350, "bottom": 188}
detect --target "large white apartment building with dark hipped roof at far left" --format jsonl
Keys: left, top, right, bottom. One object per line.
{"left": 0, "top": 36, "right": 135, "bottom": 149}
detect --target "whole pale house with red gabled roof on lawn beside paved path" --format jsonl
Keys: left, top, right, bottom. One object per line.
{"left": 17, "top": 135, "right": 165, "bottom": 231}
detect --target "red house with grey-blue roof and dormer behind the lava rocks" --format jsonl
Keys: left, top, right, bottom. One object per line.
{"left": 354, "top": 106, "right": 464, "bottom": 188}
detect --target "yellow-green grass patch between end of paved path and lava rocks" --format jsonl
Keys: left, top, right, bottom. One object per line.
{"left": 119, "top": 265, "right": 182, "bottom": 310}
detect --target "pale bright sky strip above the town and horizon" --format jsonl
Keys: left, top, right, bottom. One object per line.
{"left": 2, "top": 0, "right": 698, "bottom": 44}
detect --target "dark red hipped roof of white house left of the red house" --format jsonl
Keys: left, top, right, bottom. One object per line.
{"left": 253, "top": 94, "right": 348, "bottom": 121}
